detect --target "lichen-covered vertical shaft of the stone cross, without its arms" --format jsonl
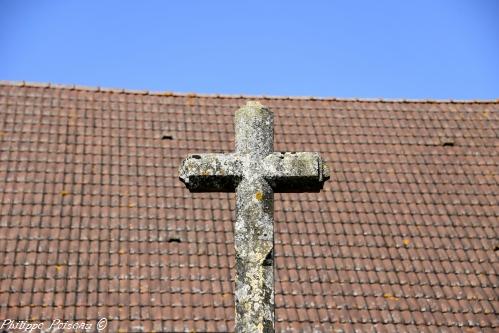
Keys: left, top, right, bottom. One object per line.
{"left": 235, "top": 103, "right": 274, "bottom": 332}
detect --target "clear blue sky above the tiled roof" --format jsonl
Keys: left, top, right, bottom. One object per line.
{"left": 0, "top": 0, "right": 499, "bottom": 99}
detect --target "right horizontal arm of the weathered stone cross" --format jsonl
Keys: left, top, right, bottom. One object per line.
{"left": 262, "top": 152, "right": 329, "bottom": 192}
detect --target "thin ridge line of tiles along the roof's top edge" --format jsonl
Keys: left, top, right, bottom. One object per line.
{"left": 0, "top": 80, "right": 499, "bottom": 104}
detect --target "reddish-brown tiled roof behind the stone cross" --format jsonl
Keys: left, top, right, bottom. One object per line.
{"left": 0, "top": 82, "right": 499, "bottom": 332}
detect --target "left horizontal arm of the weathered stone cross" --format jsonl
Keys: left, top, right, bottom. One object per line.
{"left": 179, "top": 154, "right": 242, "bottom": 192}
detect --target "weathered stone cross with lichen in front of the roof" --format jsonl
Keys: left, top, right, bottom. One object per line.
{"left": 180, "top": 102, "right": 329, "bottom": 333}
